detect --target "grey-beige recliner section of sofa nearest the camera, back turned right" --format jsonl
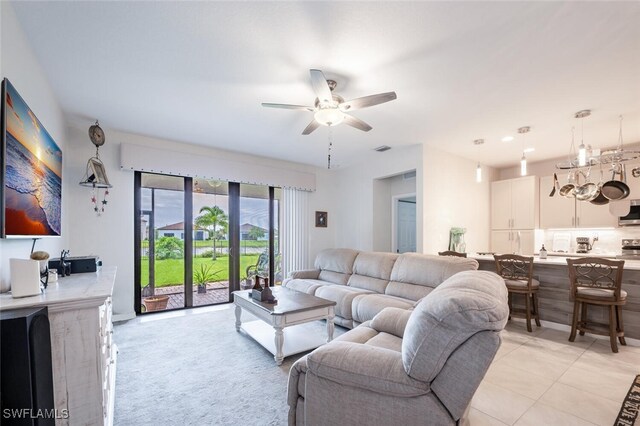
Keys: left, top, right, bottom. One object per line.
{"left": 287, "top": 272, "right": 509, "bottom": 426}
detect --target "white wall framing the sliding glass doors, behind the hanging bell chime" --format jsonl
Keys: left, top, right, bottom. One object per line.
{"left": 67, "top": 123, "right": 336, "bottom": 319}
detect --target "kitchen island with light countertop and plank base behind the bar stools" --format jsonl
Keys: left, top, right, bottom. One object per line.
{"left": 469, "top": 254, "right": 640, "bottom": 339}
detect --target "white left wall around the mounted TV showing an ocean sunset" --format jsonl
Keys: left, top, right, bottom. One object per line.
{"left": 0, "top": 1, "right": 69, "bottom": 290}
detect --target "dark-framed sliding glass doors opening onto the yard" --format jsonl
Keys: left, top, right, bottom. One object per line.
{"left": 134, "top": 172, "right": 282, "bottom": 313}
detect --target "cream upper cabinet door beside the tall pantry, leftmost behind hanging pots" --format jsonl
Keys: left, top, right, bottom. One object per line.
{"left": 540, "top": 174, "right": 576, "bottom": 229}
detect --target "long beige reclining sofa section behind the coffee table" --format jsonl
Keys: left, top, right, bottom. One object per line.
{"left": 282, "top": 249, "right": 478, "bottom": 328}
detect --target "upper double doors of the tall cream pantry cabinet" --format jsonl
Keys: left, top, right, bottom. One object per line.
{"left": 491, "top": 176, "right": 539, "bottom": 230}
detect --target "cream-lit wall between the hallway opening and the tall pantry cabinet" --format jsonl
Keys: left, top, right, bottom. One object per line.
{"left": 418, "top": 145, "right": 498, "bottom": 254}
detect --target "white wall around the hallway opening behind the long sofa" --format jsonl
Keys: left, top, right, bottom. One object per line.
{"left": 335, "top": 145, "right": 422, "bottom": 251}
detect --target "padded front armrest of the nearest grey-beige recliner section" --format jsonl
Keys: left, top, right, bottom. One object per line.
{"left": 307, "top": 342, "right": 430, "bottom": 397}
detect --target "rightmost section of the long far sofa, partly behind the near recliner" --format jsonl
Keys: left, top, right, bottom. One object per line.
{"left": 385, "top": 253, "right": 478, "bottom": 300}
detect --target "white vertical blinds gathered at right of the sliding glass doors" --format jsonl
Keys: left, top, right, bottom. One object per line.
{"left": 282, "top": 188, "right": 310, "bottom": 278}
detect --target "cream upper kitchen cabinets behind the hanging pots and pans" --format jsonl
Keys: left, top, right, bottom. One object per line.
{"left": 540, "top": 174, "right": 618, "bottom": 229}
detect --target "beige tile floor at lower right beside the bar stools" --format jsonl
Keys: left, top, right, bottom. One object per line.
{"left": 469, "top": 319, "right": 640, "bottom": 426}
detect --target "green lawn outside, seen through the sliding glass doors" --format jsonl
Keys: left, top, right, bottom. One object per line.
{"left": 140, "top": 255, "right": 258, "bottom": 287}
